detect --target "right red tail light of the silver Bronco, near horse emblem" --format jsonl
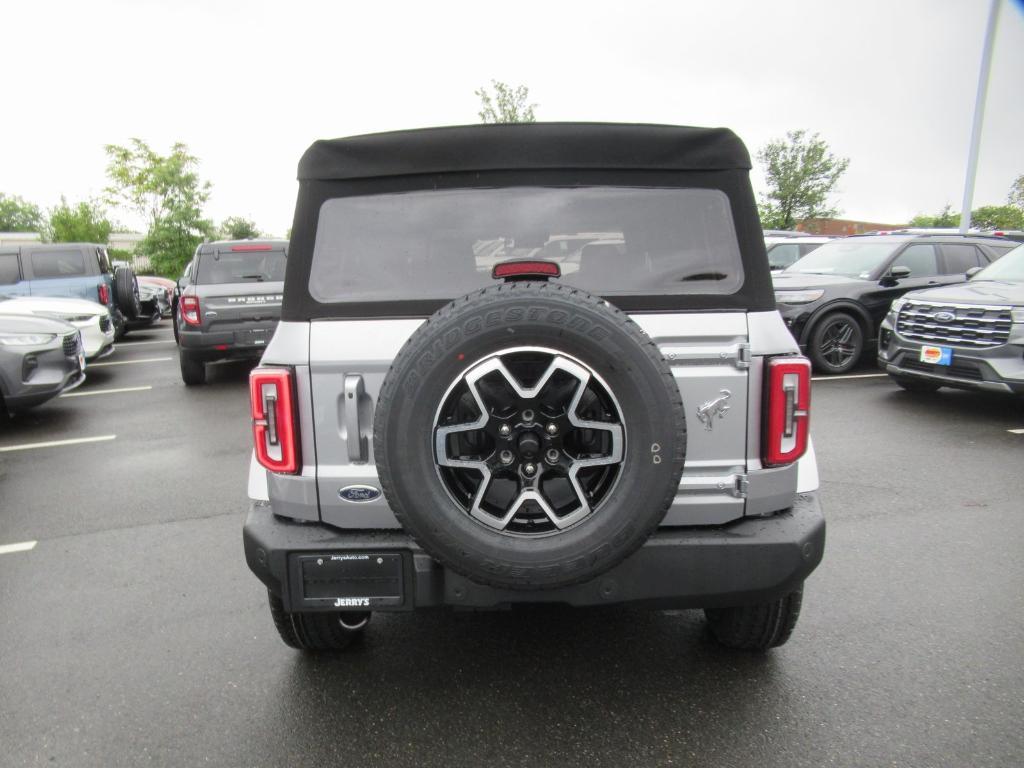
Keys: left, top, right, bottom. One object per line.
{"left": 761, "top": 357, "right": 811, "bottom": 467}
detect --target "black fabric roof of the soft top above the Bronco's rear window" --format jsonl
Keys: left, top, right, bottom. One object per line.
{"left": 298, "top": 123, "right": 751, "bottom": 181}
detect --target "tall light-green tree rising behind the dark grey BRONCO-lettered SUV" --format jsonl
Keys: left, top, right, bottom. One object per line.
{"left": 104, "top": 138, "right": 213, "bottom": 276}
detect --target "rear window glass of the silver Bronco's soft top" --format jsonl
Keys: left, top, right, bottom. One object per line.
{"left": 309, "top": 186, "right": 743, "bottom": 303}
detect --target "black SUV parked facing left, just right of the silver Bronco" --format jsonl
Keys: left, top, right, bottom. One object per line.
{"left": 773, "top": 234, "right": 1017, "bottom": 374}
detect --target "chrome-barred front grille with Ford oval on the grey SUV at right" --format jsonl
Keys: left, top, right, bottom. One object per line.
{"left": 896, "top": 301, "right": 1013, "bottom": 347}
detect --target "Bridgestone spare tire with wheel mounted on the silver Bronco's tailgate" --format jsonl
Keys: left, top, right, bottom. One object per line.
{"left": 374, "top": 282, "right": 686, "bottom": 590}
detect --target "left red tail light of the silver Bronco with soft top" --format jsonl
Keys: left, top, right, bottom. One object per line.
{"left": 249, "top": 368, "right": 299, "bottom": 475}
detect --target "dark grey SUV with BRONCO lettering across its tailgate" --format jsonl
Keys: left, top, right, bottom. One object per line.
{"left": 174, "top": 240, "right": 288, "bottom": 386}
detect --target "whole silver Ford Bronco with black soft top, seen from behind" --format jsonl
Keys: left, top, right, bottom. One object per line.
{"left": 244, "top": 124, "right": 825, "bottom": 651}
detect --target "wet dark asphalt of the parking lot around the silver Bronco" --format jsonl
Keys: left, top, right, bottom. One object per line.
{"left": 0, "top": 323, "right": 1024, "bottom": 766}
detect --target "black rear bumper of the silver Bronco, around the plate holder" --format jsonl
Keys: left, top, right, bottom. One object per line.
{"left": 243, "top": 494, "right": 825, "bottom": 611}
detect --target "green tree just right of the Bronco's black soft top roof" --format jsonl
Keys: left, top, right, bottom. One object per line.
{"left": 758, "top": 131, "right": 850, "bottom": 229}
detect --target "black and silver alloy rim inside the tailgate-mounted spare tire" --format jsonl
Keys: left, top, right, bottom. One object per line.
{"left": 434, "top": 347, "right": 625, "bottom": 536}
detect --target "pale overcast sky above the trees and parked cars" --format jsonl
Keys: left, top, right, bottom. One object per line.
{"left": 0, "top": 0, "right": 1024, "bottom": 234}
